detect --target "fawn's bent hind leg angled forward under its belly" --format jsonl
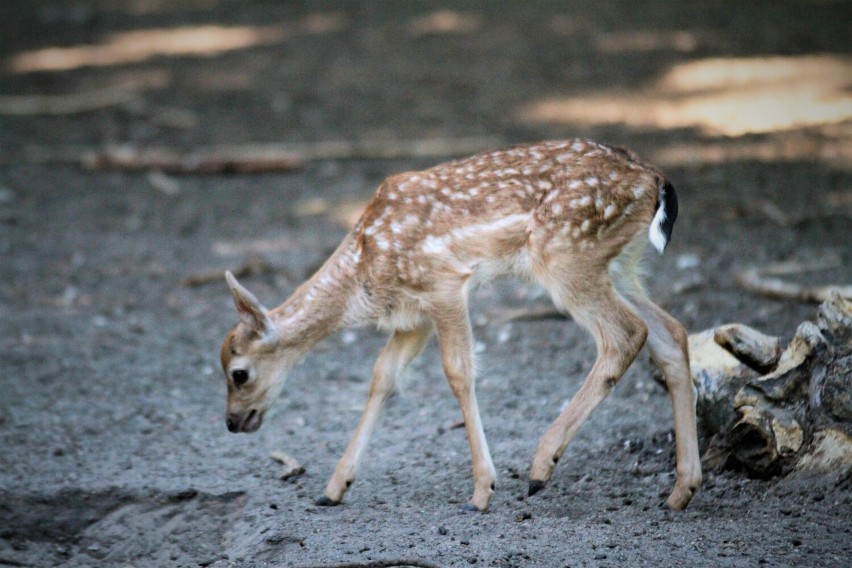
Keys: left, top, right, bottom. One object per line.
{"left": 529, "top": 278, "right": 648, "bottom": 495}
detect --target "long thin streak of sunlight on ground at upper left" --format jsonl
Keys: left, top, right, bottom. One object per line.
{"left": 6, "top": 12, "right": 346, "bottom": 73}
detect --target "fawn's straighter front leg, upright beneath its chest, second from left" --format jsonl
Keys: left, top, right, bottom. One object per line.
{"left": 436, "top": 302, "right": 497, "bottom": 511}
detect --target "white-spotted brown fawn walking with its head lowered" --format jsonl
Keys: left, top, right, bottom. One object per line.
{"left": 221, "top": 140, "right": 701, "bottom": 511}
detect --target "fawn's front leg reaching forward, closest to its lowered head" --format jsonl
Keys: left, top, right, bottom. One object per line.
{"left": 317, "top": 324, "right": 432, "bottom": 505}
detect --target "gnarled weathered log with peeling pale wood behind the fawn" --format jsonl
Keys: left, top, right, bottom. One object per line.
{"left": 689, "top": 292, "right": 852, "bottom": 477}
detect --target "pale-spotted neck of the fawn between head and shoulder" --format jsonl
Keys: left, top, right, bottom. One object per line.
{"left": 271, "top": 234, "right": 360, "bottom": 352}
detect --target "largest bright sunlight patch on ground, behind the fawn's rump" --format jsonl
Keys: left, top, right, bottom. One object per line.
{"left": 520, "top": 56, "right": 852, "bottom": 136}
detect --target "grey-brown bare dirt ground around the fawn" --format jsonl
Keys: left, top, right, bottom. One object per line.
{"left": 0, "top": 0, "right": 852, "bottom": 567}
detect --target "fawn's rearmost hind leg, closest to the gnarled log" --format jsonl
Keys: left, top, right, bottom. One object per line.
{"left": 627, "top": 282, "right": 701, "bottom": 510}
